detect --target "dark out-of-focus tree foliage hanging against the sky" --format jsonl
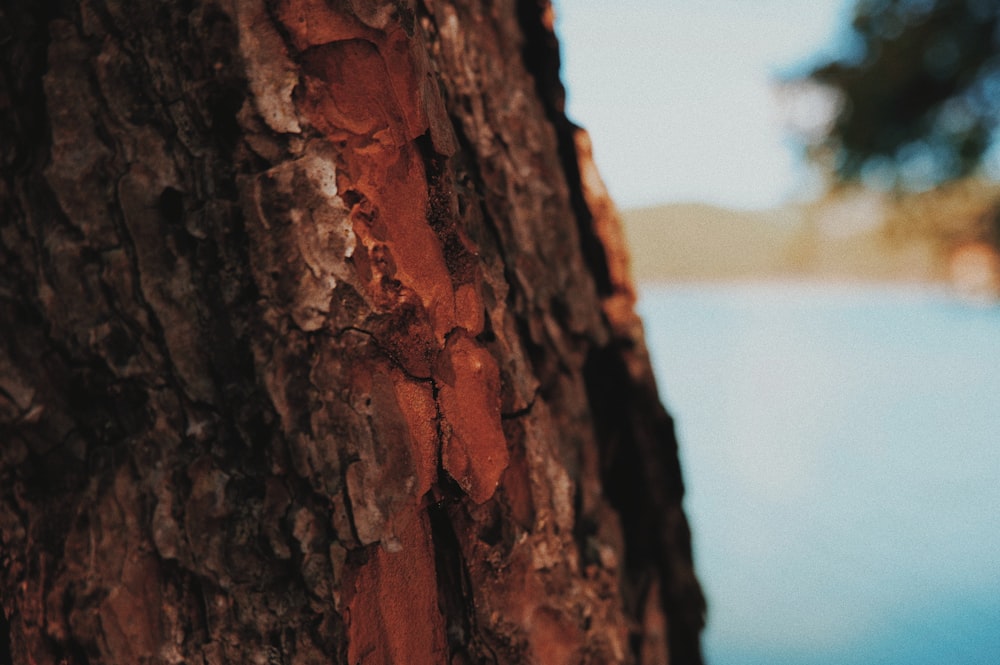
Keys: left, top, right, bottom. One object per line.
{"left": 805, "top": 0, "right": 1000, "bottom": 189}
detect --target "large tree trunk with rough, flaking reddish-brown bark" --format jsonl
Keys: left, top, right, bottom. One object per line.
{"left": 0, "top": 0, "right": 703, "bottom": 665}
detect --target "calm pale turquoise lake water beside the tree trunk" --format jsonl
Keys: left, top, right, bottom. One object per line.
{"left": 640, "top": 284, "right": 1000, "bottom": 665}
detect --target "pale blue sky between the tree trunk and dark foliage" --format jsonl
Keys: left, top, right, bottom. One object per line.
{"left": 555, "top": 0, "right": 853, "bottom": 209}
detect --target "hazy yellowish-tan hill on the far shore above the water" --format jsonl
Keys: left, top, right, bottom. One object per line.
{"left": 622, "top": 201, "right": 941, "bottom": 282}
